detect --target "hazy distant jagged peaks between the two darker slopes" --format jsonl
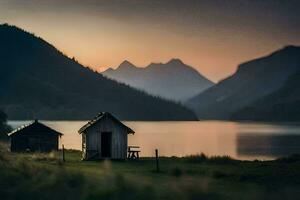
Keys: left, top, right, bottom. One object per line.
{"left": 102, "top": 59, "right": 214, "bottom": 102}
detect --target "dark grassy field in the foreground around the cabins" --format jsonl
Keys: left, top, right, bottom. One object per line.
{"left": 0, "top": 144, "right": 300, "bottom": 200}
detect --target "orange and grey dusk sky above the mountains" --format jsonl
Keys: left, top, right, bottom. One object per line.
{"left": 0, "top": 0, "right": 300, "bottom": 82}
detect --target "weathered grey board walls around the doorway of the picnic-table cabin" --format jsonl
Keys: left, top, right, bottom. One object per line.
{"left": 82, "top": 118, "right": 127, "bottom": 159}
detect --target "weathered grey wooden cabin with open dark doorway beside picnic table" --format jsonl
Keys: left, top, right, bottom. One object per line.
{"left": 78, "top": 112, "right": 134, "bottom": 160}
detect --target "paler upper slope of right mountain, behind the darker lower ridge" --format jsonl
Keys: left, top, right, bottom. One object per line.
{"left": 187, "top": 46, "right": 300, "bottom": 119}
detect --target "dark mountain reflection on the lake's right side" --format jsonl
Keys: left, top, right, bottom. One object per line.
{"left": 236, "top": 133, "right": 300, "bottom": 158}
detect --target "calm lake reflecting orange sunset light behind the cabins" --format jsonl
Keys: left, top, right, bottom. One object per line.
{"left": 9, "top": 121, "right": 300, "bottom": 160}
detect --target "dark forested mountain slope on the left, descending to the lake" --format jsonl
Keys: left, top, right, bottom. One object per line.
{"left": 0, "top": 24, "right": 196, "bottom": 120}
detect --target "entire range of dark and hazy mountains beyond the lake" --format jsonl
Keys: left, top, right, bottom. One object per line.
{"left": 0, "top": 24, "right": 300, "bottom": 121}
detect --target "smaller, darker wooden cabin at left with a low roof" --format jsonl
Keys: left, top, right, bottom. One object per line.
{"left": 8, "top": 120, "right": 63, "bottom": 152}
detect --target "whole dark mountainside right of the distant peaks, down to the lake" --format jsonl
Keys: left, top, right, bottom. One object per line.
{"left": 186, "top": 46, "right": 300, "bottom": 120}
